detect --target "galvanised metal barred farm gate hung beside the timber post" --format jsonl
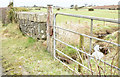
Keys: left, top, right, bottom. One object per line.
{"left": 53, "top": 13, "right": 120, "bottom": 72}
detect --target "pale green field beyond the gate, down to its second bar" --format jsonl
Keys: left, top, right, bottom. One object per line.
{"left": 30, "top": 8, "right": 118, "bottom": 35}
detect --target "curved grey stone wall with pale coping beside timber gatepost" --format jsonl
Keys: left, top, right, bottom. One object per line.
{"left": 15, "top": 12, "right": 47, "bottom": 40}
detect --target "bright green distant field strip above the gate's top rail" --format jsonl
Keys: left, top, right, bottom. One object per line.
{"left": 31, "top": 8, "right": 118, "bottom": 19}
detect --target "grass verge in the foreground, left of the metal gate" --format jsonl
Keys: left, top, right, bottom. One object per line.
{"left": 0, "top": 24, "right": 72, "bottom": 75}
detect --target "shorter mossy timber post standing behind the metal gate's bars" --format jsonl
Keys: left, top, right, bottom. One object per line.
{"left": 78, "top": 35, "right": 84, "bottom": 72}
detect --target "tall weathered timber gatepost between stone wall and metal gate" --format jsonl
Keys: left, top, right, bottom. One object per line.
{"left": 47, "top": 5, "right": 53, "bottom": 55}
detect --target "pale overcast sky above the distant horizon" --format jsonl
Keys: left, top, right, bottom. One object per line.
{"left": 0, "top": 0, "right": 119, "bottom": 7}
